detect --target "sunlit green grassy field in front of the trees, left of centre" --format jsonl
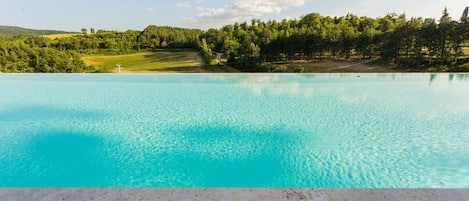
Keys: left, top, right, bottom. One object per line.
{"left": 82, "top": 51, "right": 210, "bottom": 73}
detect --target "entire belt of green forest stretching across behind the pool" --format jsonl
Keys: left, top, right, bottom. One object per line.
{"left": 0, "top": 8, "right": 469, "bottom": 73}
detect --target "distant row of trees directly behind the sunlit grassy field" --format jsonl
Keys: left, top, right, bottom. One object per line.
{"left": 52, "top": 25, "right": 202, "bottom": 54}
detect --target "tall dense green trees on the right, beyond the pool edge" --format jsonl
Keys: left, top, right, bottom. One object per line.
{"left": 201, "top": 8, "right": 469, "bottom": 71}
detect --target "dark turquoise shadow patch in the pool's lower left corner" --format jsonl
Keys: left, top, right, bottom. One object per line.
{"left": 0, "top": 131, "right": 119, "bottom": 188}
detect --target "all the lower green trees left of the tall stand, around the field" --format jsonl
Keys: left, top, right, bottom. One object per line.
{"left": 0, "top": 25, "right": 202, "bottom": 73}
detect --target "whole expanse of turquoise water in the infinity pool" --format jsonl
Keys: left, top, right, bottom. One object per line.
{"left": 0, "top": 74, "right": 469, "bottom": 188}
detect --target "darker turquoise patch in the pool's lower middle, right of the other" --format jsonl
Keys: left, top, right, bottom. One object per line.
{"left": 144, "top": 126, "right": 310, "bottom": 187}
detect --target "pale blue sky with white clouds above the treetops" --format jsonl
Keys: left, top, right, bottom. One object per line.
{"left": 0, "top": 0, "right": 469, "bottom": 31}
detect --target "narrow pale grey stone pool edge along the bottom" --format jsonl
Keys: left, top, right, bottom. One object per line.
{"left": 0, "top": 188, "right": 469, "bottom": 201}
